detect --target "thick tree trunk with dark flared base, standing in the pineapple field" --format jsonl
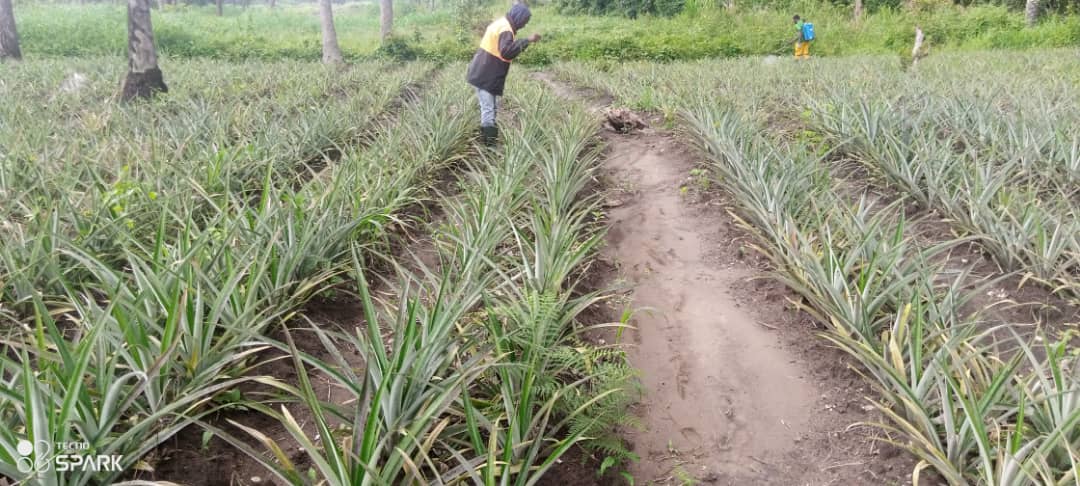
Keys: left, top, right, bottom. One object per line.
{"left": 120, "top": 0, "right": 168, "bottom": 102}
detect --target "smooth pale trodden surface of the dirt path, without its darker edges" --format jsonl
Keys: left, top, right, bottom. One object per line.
{"left": 606, "top": 133, "right": 820, "bottom": 484}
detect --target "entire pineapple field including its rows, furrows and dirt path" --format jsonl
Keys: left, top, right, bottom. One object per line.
{"left": 0, "top": 49, "right": 1080, "bottom": 486}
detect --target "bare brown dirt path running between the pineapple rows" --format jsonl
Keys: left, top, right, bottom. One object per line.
{"left": 536, "top": 73, "right": 915, "bottom": 485}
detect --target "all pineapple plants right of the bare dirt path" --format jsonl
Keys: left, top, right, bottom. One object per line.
{"left": 555, "top": 53, "right": 1080, "bottom": 485}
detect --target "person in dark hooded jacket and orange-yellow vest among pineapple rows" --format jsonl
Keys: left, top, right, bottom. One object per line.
{"left": 465, "top": 3, "right": 540, "bottom": 147}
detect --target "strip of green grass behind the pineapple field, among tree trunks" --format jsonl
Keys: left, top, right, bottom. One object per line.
{"left": 17, "top": 1, "right": 1080, "bottom": 65}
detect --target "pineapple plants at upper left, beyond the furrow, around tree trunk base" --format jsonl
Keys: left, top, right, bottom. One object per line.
{"left": 0, "top": 62, "right": 422, "bottom": 306}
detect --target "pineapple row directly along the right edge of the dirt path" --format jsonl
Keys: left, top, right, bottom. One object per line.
{"left": 687, "top": 106, "right": 1080, "bottom": 485}
